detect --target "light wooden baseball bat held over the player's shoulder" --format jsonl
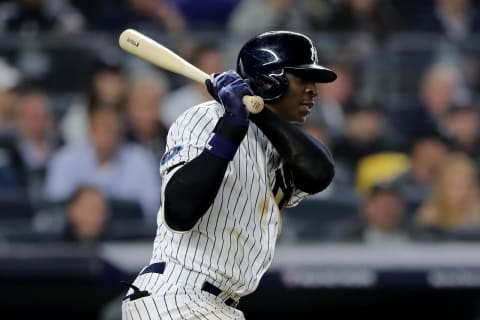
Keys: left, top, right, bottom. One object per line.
{"left": 118, "top": 29, "right": 264, "bottom": 113}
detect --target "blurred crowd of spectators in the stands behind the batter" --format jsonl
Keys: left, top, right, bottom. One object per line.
{"left": 0, "top": 0, "right": 480, "bottom": 248}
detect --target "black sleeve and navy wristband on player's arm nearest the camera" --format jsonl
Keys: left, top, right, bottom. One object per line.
{"left": 163, "top": 120, "right": 248, "bottom": 231}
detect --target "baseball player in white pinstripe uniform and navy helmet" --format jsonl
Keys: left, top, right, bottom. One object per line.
{"left": 122, "top": 31, "right": 336, "bottom": 320}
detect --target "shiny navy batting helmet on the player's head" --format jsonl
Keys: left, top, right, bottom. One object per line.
{"left": 237, "top": 31, "right": 337, "bottom": 101}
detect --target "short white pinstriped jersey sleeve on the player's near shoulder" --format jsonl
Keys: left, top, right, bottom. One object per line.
{"left": 160, "top": 103, "right": 220, "bottom": 176}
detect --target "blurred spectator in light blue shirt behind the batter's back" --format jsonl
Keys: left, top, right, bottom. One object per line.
{"left": 45, "top": 104, "right": 160, "bottom": 223}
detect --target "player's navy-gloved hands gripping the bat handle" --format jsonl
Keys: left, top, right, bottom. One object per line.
{"left": 205, "top": 70, "right": 253, "bottom": 124}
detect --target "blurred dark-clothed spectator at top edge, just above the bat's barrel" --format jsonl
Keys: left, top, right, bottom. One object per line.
{"left": 90, "top": 0, "right": 187, "bottom": 34}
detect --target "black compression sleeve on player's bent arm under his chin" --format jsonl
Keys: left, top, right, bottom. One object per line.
{"left": 250, "top": 108, "right": 335, "bottom": 193}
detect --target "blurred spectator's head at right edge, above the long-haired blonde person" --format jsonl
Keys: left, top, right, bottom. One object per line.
{"left": 446, "top": 105, "right": 480, "bottom": 167}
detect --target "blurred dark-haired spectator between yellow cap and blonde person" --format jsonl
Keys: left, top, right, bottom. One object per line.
{"left": 395, "top": 129, "right": 450, "bottom": 211}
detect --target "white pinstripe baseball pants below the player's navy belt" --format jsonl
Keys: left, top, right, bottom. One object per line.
{"left": 122, "top": 263, "right": 245, "bottom": 320}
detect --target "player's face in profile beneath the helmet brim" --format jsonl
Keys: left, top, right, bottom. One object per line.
{"left": 269, "top": 72, "right": 317, "bottom": 124}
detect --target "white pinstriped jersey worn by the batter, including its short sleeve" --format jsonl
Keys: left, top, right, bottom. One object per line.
{"left": 151, "top": 101, "right": 307, "bottom": 296}
